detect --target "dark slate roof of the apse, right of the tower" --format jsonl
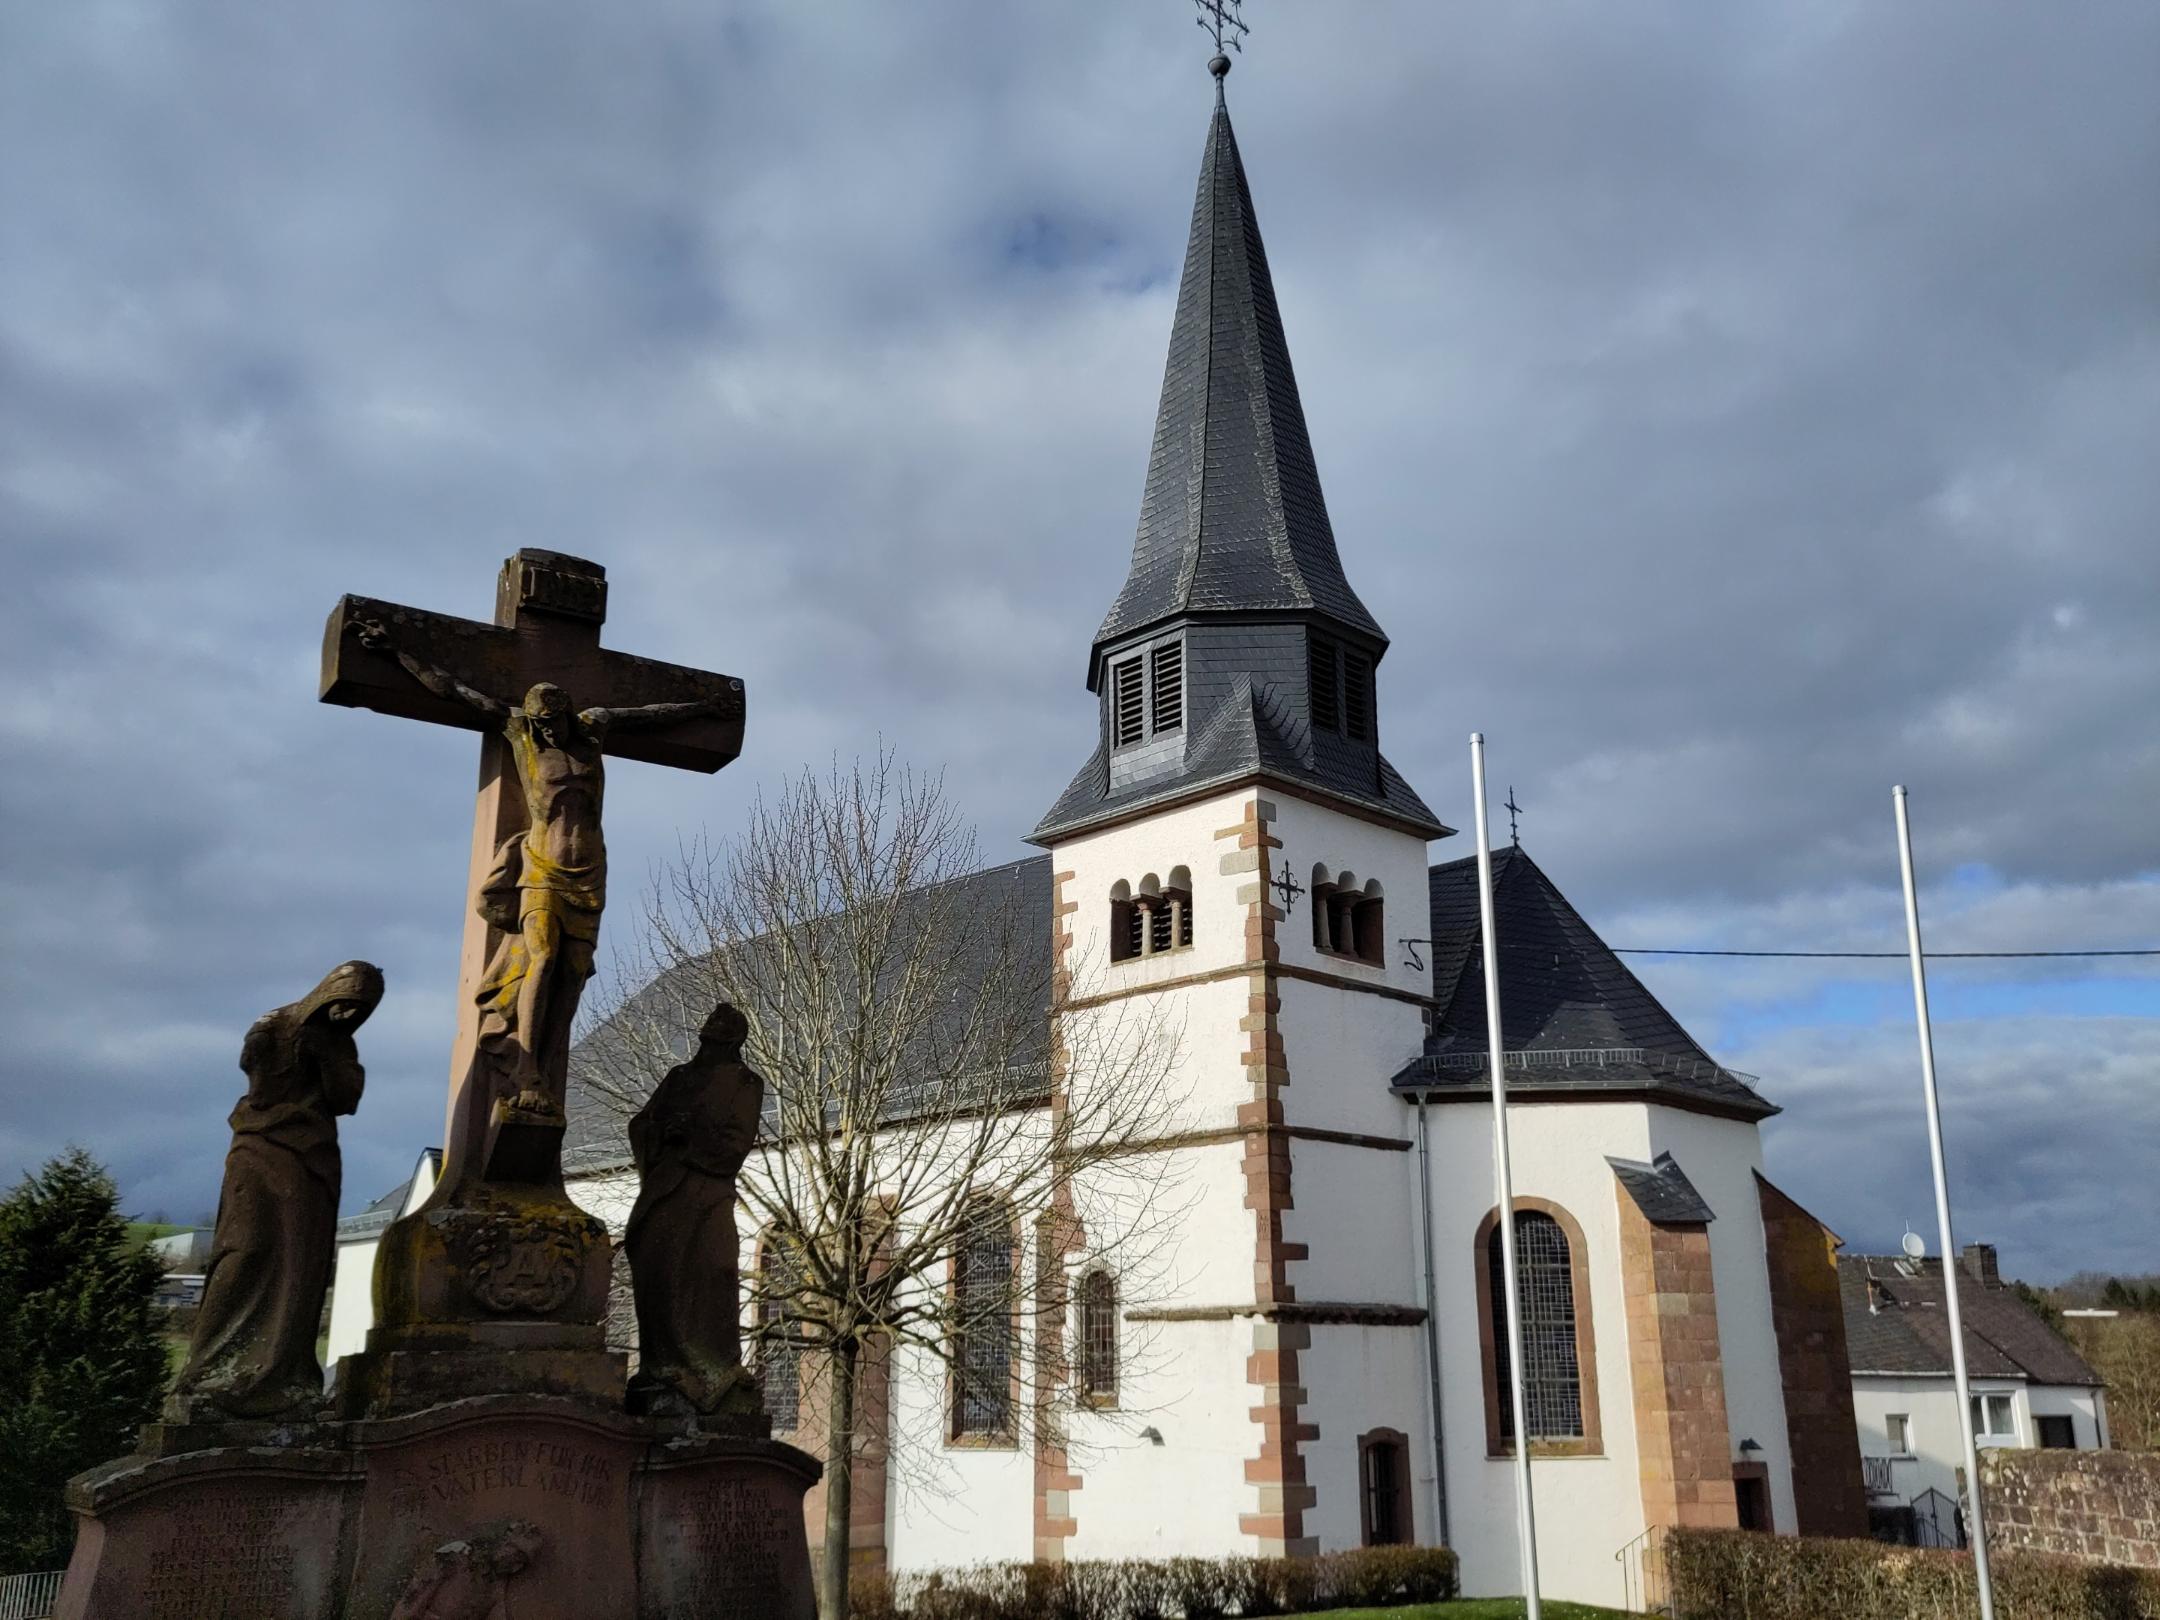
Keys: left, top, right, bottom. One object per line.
{"left": 1395, "top": 847, "right": 1778, "bottom": 1119}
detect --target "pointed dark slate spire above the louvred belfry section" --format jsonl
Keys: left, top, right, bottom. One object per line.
{"left": 1089, "top": 68, "right": 1387, "bottom": 685}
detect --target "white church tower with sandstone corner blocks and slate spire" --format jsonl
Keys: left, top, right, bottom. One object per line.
{"left": 1030, "top": 56, "right": 1449, "bottom": 1557}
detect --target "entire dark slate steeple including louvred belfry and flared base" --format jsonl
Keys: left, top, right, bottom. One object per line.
{"left": 1032, "top": 63, "right": 1447, "bottom": 845}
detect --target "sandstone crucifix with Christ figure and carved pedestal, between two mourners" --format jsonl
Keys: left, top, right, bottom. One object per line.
{"left": 320, "top": 551, "right": 743, "bottom": 1415}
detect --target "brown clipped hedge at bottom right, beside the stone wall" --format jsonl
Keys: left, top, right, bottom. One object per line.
{"left": 1665, "top": 1529, "right": 2160, "bottom": 1620}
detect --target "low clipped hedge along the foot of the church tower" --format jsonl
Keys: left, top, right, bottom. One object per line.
{"left": 849, "top": 1547, "right": 1456, "bottom": 1620}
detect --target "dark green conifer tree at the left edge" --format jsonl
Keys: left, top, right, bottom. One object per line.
{"left": 0, "top": 1147, "right": 168, "bottom": 1575}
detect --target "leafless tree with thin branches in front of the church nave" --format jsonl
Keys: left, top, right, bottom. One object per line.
{"left": 577, "top": 756, "right": 1177, "bottom": 1620}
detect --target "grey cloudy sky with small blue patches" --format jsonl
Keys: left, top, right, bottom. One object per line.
{"left": 0, "top": 0, "right": 2160, "bottom": 1279}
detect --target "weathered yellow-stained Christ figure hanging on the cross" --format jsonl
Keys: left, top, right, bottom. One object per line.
{"left": 352, "top": 620, "right": 726, "bottom": 1119}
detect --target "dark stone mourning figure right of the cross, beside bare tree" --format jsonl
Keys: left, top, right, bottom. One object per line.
{"left": 622, "top": 1002, "right": 765, "bottom": 1413}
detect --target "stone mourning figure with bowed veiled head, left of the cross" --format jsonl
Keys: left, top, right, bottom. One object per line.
{"left": 173, "top": 961, "right": 382, "bottom": 1417}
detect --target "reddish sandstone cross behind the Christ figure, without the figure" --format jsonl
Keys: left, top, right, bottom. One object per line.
{"left": 320, "top": 549, "right": 743, "bottom": 1182}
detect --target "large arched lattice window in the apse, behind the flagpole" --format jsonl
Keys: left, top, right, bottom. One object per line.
{"left": 1477, "top": 1199, "right": 1601, "bottom": 1456}
